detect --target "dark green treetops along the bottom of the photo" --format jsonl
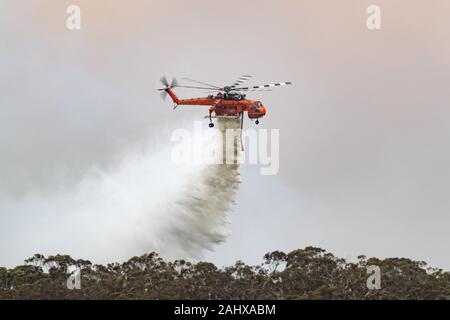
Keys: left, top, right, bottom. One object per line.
{"left": 0, "top": 247, "right": 450, "bottom": 299}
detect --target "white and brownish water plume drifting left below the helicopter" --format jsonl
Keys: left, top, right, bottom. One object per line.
{"left": 0, "top": 120, "right": 240, "bottom": 262}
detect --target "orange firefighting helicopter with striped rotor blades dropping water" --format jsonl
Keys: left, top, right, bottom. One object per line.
{"left": 158, "top": 75, "right": 292, "bottom": 129}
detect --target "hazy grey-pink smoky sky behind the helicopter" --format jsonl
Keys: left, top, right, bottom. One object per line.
{"left": 0, "top": 0, "right": 450, "bottom": 270}
